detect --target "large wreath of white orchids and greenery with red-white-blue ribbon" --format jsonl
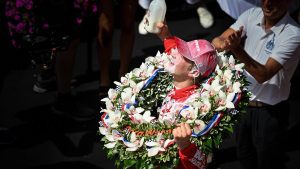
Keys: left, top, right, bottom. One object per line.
{"left": 99, "top": 52, "right": 250, "bottom": 169}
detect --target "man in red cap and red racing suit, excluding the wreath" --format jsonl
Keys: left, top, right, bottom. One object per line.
{"left": 154, "top": 25, "right": 218, "bottom": 169}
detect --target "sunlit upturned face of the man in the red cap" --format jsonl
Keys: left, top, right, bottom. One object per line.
{"left": 165, "top": 48, "right": 192, "bottom": 77}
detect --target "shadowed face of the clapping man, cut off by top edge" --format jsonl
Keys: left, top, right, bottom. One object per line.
{"left": 261, "top": 0, "right": 290, "bottom": 20}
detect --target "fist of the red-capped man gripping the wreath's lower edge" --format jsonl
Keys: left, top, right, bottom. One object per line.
{"left": 173, "top": 123, "right": 192, "bottom": 150}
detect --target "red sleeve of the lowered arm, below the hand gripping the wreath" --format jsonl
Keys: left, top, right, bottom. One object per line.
{"left": 177, "top": 143, "right": 207, "bottom": 169}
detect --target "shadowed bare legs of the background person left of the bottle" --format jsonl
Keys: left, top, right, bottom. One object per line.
{"left": 97, "top": 0, "right": 137, "bottom": 95}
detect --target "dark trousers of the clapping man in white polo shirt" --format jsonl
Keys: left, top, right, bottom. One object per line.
{"left": 236, "top": 101, "right": 289, "bottom": 169}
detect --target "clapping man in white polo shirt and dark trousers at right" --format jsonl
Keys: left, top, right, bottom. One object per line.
{"left": 212, "top": 0, "right": 300, "bottom": 169}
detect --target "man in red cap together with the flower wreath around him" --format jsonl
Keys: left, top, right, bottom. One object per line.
{"left": 99, "top": 18, "right": 248, "bottom": 169}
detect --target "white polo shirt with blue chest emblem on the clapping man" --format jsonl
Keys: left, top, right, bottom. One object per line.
{"left": 231, "top": 8, "right": 300, "bottom": 105}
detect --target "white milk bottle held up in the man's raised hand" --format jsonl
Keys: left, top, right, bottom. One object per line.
{"left": 144, "top": 0, "right": 167, "bottom": 33}
